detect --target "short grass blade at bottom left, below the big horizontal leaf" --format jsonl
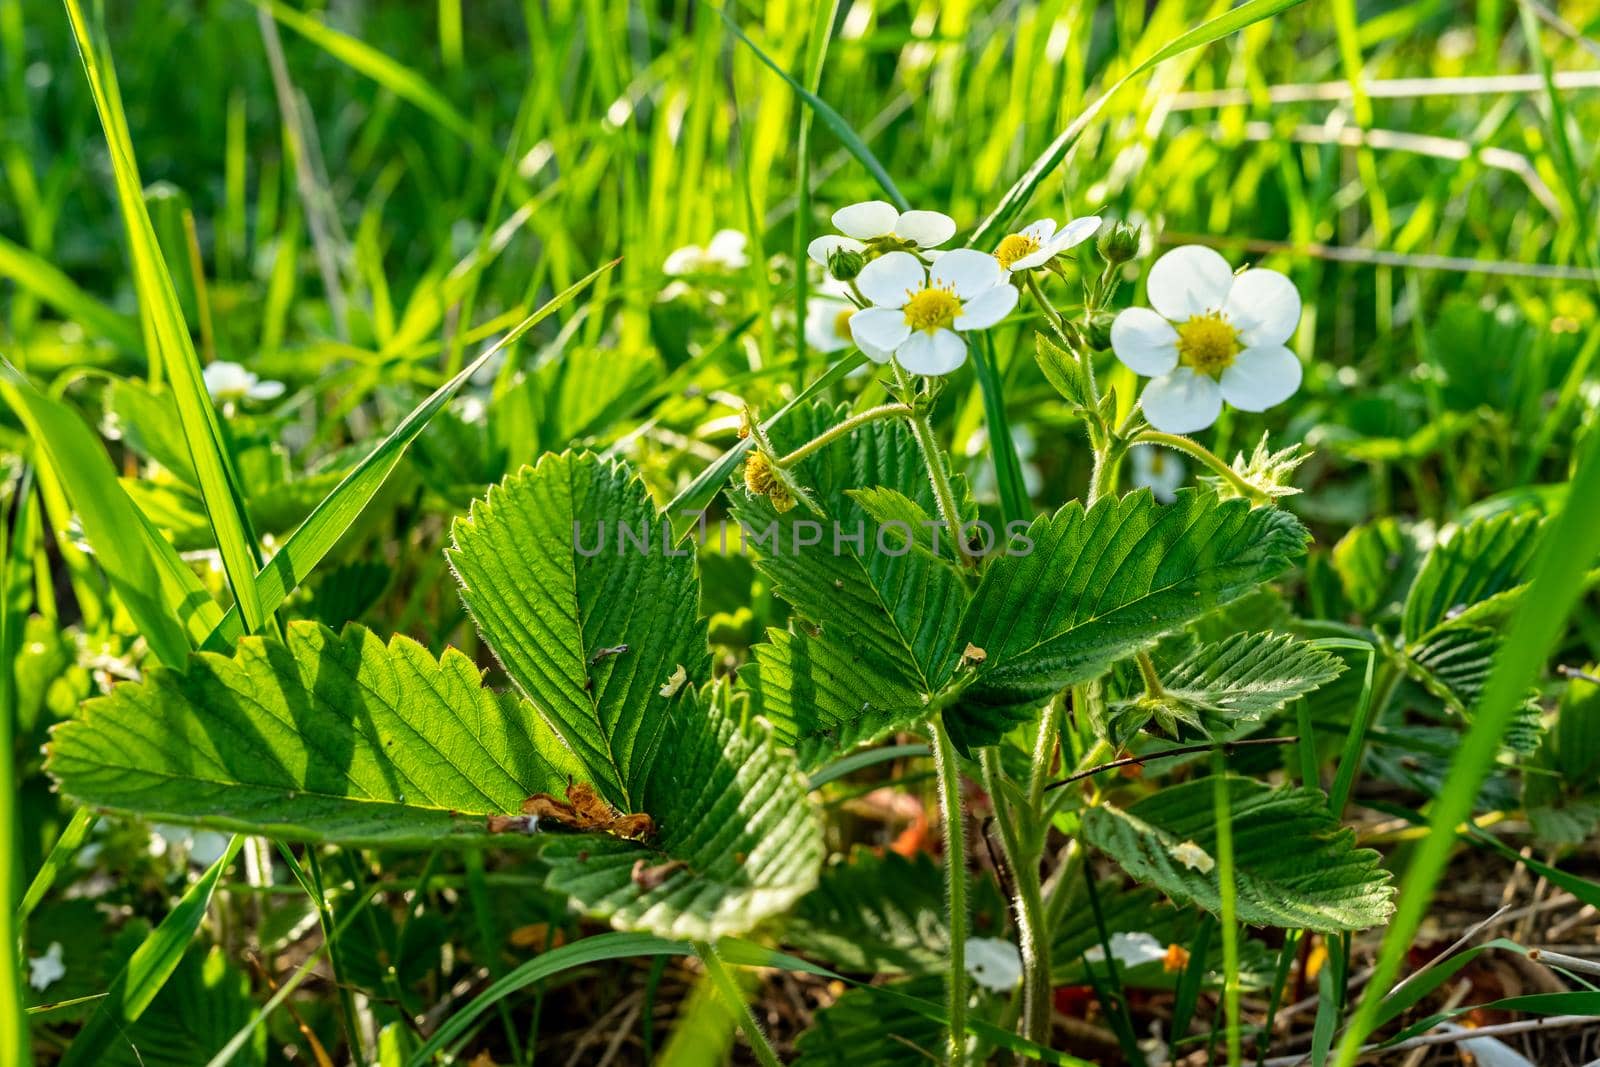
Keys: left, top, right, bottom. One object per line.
{"left": 61, "top": 835, "right": 245, "bottom": 1067}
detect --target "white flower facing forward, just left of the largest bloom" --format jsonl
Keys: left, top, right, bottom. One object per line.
{"left": 850, "top": 248, "right": 1016, "bottom": 374}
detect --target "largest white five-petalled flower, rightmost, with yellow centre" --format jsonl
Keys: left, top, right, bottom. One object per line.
{"left": 1110, "top": 245, "right": 1301, "bottom": 434}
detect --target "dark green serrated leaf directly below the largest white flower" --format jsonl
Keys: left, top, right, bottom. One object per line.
{"left": 947, "top": 490, "right": 1307, "bottom": 744}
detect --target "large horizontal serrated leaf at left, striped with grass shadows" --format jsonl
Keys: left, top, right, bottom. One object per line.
{"left": 46, "top": 622, "right": 582, "bottom": 846}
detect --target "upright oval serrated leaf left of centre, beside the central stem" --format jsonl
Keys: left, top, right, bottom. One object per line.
{"left": 448, "top": 453, "right": 710, "bottom": 811}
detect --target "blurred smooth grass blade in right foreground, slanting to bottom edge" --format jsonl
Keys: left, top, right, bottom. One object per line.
{"left": 1336, "top": 434, "right": 1600, "bottom": 1067}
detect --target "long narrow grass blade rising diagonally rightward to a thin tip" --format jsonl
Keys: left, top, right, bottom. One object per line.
{"left": 203, "top": 259, "right": 618, "bottom": 651}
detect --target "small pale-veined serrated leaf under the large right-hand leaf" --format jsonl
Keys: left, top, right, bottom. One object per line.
{"left": 1110, "top": 633, "right": 1344, "bottom": 742}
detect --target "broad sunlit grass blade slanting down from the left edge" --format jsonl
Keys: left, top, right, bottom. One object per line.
{"left": 0, "top": 360, "right": 222, "bottom": 669}
